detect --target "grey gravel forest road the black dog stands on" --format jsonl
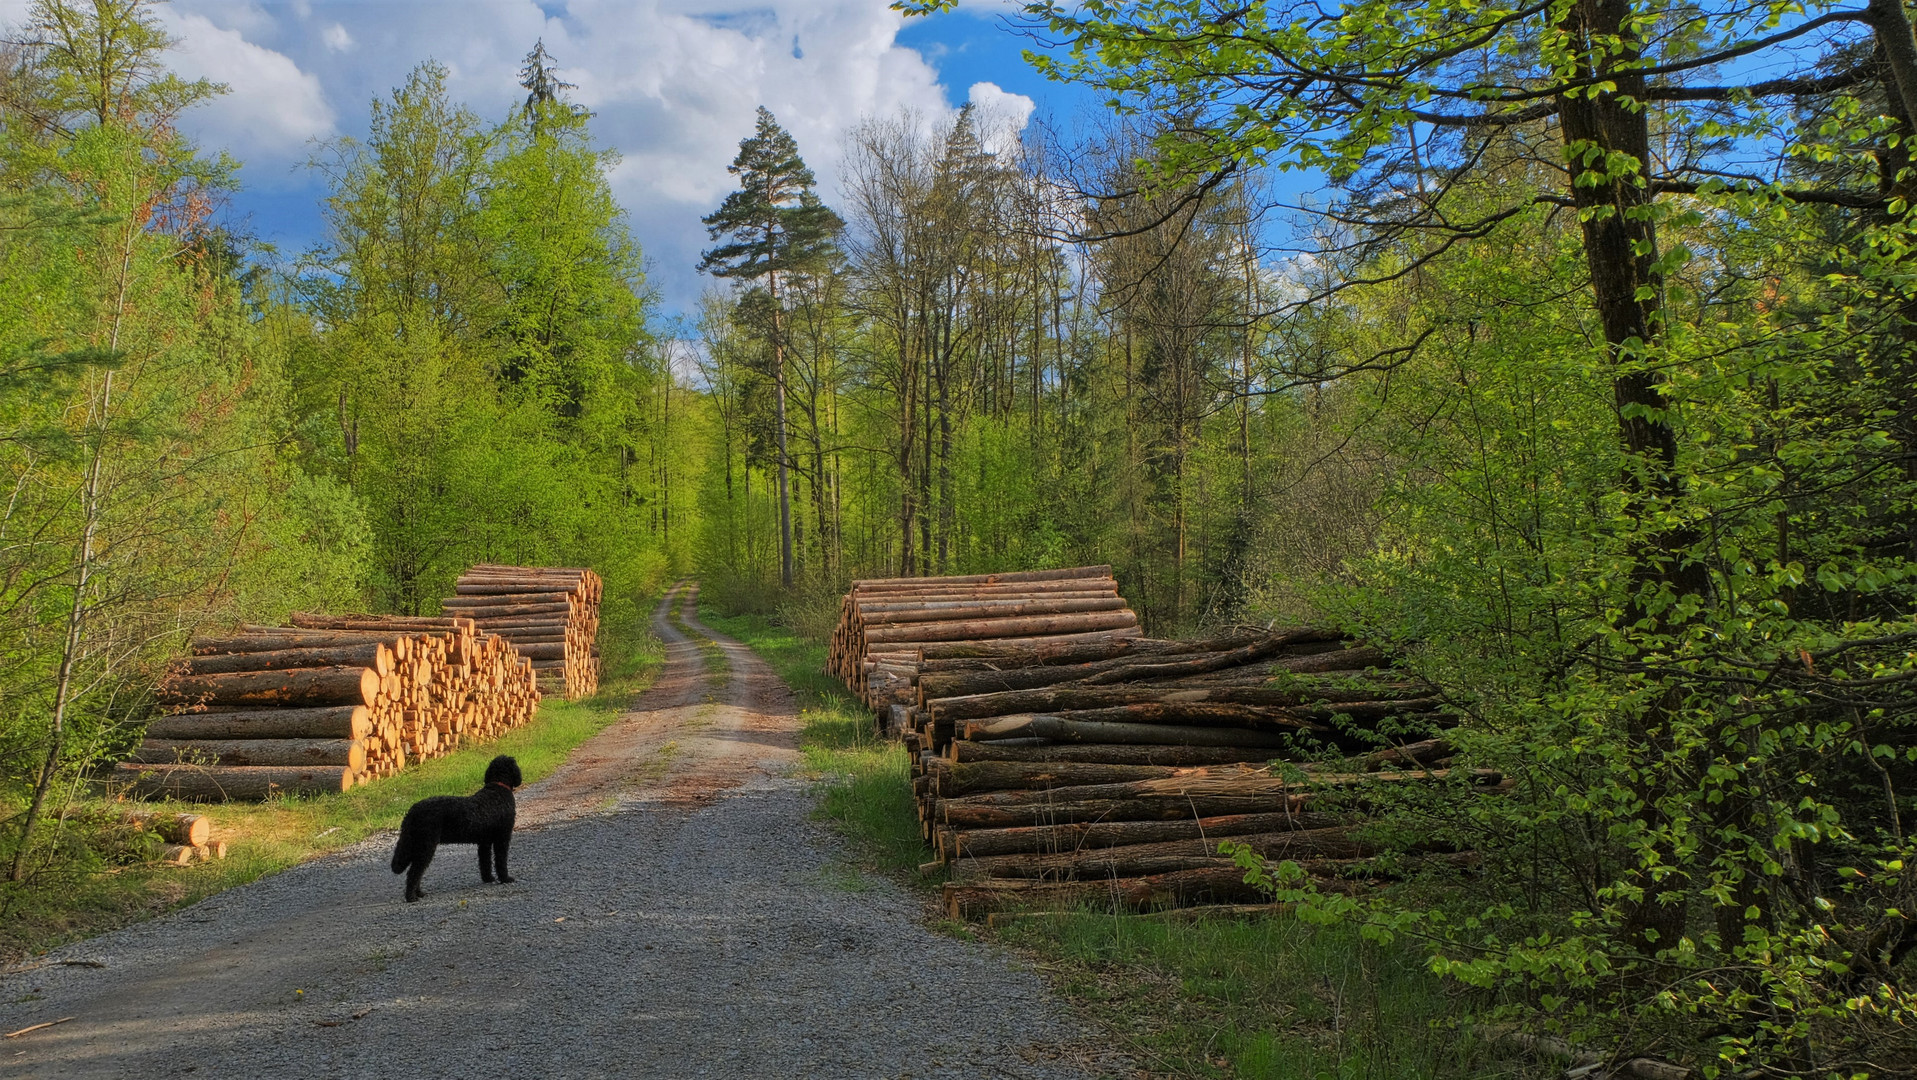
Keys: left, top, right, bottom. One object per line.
{"left": 0, "top": 585, "right": 1095, "bottom": 1080}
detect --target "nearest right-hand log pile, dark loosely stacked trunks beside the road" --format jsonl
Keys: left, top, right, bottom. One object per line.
{"left": 895, "top": 627, "right": 1479, "bottom": 919}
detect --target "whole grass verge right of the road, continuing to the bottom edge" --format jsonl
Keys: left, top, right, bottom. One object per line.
{"left": 700, "top": 594, "right": 1505, "bottom": 1080}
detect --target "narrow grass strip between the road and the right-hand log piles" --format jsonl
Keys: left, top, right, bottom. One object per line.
{"left": 700, "top": 604, "right": 926, "bottom": 875}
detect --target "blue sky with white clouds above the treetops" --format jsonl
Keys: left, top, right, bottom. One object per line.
{"left": 0, "top": 0, "right": 1111, "bottom": 315}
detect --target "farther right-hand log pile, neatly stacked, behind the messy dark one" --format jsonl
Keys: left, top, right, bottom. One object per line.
{"left": 826, "top": 566, "right": 1139, "bottom": 714}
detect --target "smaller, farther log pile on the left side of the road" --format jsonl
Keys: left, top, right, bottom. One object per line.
{"left": 439, "top": 562, "right": 606, "bottom": 700}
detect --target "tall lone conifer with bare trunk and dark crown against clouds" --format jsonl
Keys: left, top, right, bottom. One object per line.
{"left": 700, "top": 106, "right": 845, "bottom": 585}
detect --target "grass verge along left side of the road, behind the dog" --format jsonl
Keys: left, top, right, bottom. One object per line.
{"left": 0, "top": 613, "right": 663, "bottom": 965}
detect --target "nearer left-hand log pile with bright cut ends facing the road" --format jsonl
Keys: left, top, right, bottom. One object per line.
{"left": 115, "top": 614, "right": 539, "bottom": 802}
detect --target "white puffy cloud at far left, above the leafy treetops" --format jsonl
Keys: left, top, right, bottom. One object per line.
{"left": 167, "top": 13, "right": 334, "bottom": 159}
